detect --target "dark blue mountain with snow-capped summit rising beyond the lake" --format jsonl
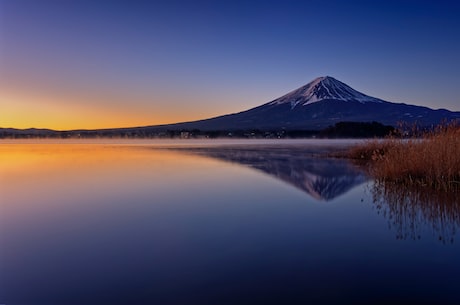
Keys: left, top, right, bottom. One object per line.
{"left": 146, "top": 76, "right": 460, "bottom": 130}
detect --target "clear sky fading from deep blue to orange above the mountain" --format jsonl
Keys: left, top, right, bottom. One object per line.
{"left": 0, "top": 0, "right": 460, "bottom": 130}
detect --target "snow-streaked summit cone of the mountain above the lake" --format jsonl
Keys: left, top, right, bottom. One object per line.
{"left": 269, "top": 76, "right": 383, "bottom": 108}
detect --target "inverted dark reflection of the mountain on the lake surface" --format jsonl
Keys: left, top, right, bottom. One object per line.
{"left": 167, "top": 145, "right": 368, "bottom": 201}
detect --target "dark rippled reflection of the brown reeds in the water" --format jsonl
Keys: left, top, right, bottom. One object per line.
{"left": 372, "top": 181, "right": 460, "bottom": 243}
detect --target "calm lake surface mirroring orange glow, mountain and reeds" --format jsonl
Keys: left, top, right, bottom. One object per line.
{"left": 0, "top": 140, "right": 460, "bottom": 305}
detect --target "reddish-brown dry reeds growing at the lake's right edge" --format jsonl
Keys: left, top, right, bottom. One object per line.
{"left": 348, "top": 124, "right": 460, "bottom": 191}
